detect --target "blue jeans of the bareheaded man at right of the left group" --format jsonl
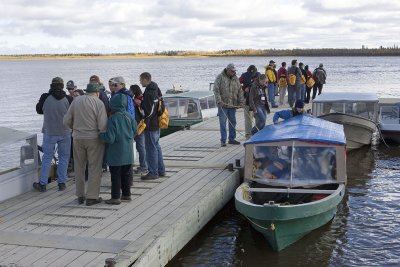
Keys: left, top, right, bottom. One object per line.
{"left": 144, "top": 130, "right": 165, "bottom": 176}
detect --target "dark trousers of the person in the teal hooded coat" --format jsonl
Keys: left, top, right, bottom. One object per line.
{"left": 110, "top": 164, "right": 132, "bottom": 199}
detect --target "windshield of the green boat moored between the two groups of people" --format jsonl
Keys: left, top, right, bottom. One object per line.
{"left": 164, "top": 97, "right": 201, "bottom": 119}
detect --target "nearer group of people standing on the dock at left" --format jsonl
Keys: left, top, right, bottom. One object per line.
{"left": 33, "top": 72, "right": 165, "bottom": 206}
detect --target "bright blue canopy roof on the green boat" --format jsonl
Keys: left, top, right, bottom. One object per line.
{"left": 244, "top": 115, "right": 346, "bottom": 145}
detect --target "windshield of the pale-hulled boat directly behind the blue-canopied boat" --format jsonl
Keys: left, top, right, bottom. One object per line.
{"left": 313, "top": 102, "right": 377, "bottom": 121}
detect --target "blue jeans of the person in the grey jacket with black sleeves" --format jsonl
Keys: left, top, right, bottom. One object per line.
{"left": 39, "top": 134, "right": 71, "bottom": 185}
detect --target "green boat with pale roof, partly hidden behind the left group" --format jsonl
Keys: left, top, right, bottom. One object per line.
{"left": 161, "top": 91, "right": 218, "bottom": 136}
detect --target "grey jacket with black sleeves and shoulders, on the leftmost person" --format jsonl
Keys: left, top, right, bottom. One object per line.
{"left": 36, "top": 88, "right": 72, "bottom": 135}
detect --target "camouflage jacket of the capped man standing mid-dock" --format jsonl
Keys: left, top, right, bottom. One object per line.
{"left": 214, "top": 69, "right": 244, "bottom": 108}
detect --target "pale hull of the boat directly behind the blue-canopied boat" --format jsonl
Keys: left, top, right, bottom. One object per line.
{"left": 319, "top": 113, "right": 376, "bottom": 150}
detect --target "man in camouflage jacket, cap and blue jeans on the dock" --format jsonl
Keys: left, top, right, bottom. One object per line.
{"left": 214, "top": 63, "right": 244, "bottom": 146}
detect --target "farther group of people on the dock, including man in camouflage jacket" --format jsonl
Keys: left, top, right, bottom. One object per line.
{"left": 214, "top": 59, "right": 327, "bottom": 142}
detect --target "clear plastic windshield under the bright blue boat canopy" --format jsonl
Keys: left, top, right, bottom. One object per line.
{"left": 253, "top": 145, "right": 337, "bottom": 187}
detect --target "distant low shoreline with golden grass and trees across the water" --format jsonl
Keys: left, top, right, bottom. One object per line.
{"left": 0, "top": 46, "right": 400, "bottom": 60}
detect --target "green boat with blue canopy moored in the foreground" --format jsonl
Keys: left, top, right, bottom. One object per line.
{"left": 235, "top": 115, "right": 347, "bottom": 251}
